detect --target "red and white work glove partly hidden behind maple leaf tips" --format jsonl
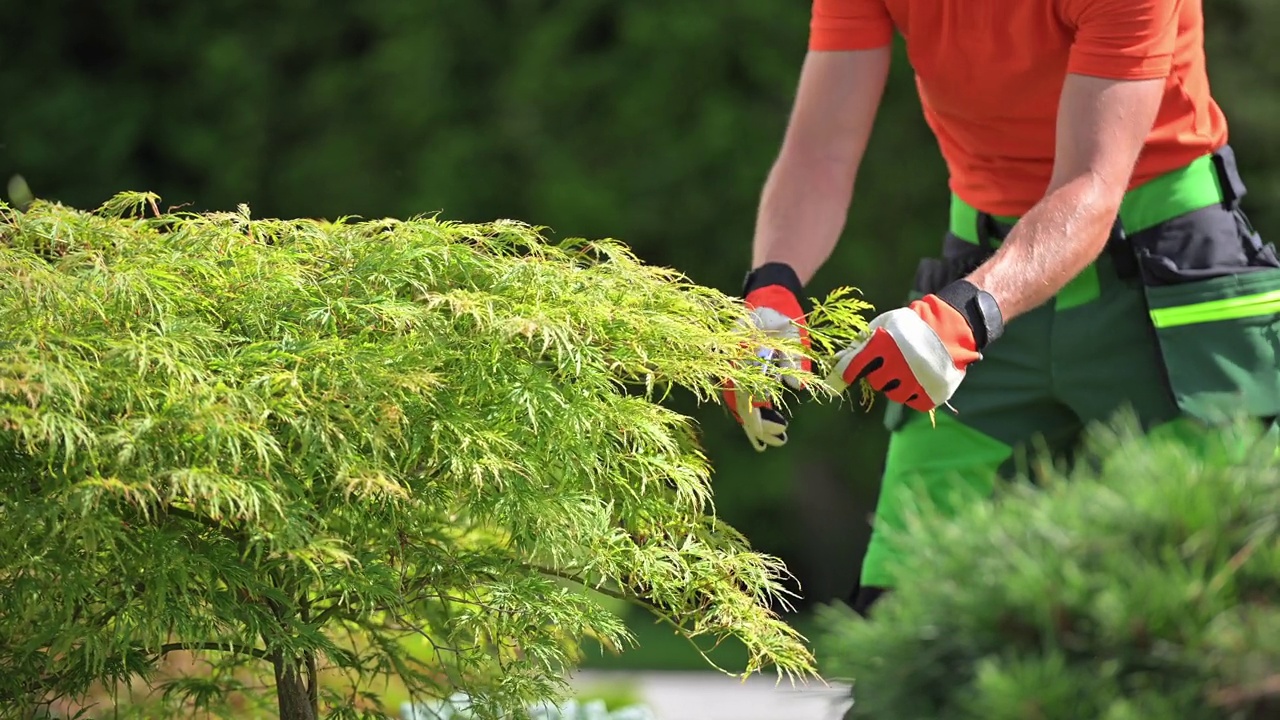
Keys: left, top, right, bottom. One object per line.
{"left": 724, "top": 263, "right": 812, "bottom": 451}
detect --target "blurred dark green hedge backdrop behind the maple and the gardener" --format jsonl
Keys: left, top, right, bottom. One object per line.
{"left": 0, "top": 0, "right": 1280, "bottom": 665}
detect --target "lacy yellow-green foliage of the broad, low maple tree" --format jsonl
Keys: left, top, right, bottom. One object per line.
{"left": 0, "top": 195, "right": 861, "bottom": 716}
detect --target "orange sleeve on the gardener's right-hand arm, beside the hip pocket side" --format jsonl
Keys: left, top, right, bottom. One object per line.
{"left": 1064, "top": 0, "right": 1183, "bottom": 79}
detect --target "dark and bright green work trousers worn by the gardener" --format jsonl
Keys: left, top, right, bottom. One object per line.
{"left": 860, "top": 147, "right": 1280, "bottom": 594}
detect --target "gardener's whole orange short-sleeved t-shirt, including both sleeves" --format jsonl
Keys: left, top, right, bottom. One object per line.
{"left": 809, "top": 0, "right": 1226, "bottom": 215}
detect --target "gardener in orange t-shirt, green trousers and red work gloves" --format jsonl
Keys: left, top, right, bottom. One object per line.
{"left": 727, "top": 0, "right": 1280, "bottom": 612}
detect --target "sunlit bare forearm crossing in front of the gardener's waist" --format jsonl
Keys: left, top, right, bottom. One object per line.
{"left": 968, "top": 176, "right": 1121, "bottom": 322}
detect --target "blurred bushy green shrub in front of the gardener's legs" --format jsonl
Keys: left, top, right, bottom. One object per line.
{"left": 818, "top": 409, "right": 1280, "bottom": 720}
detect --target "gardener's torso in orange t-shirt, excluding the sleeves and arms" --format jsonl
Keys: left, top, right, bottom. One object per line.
{"left": 883, "top": 0, "right": 1226, "bottom": 215}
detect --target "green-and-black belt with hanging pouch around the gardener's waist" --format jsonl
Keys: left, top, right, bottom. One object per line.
{"left": 913, "top": 146, "right": 1280, "bottom": 420}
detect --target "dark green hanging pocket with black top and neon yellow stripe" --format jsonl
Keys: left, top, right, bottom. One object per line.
{"left": 1130, "top": 205, "right": 1280, "bottom": 421}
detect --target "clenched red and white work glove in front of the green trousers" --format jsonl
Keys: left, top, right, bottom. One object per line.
{"left": 827, "top": 281, "right": 1005, "bottom": 413}
